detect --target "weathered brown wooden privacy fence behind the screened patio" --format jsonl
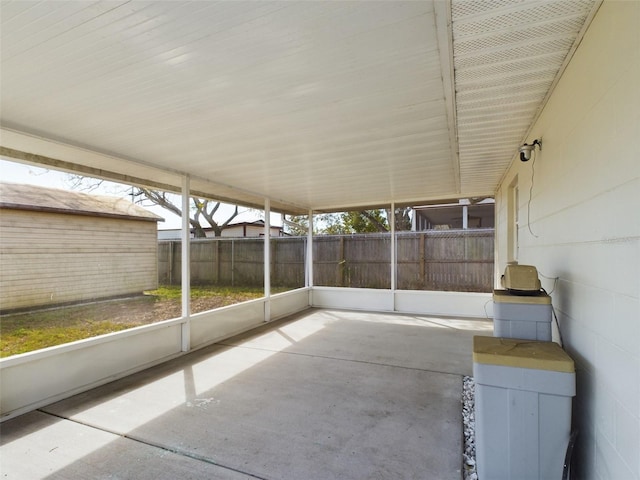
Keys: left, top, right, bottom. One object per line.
{"left": 158, "top": 229, "right": 494, "bottom": 292}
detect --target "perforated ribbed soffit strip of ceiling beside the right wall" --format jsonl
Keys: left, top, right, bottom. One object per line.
{"left": 451, "top": 0, "right": 600, "bottom": 191}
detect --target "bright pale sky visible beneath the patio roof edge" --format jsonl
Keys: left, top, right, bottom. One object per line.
{"left": 0, "top": 159, "right": 282, "bottom": 230}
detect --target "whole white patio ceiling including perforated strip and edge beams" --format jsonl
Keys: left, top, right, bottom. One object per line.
{"left": 0, "top": 0, "right": 600, "bottom": 213}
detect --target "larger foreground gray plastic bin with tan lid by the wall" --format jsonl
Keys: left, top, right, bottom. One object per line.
{"left": 473, "top": 336, "right": 576, "bottom": 480}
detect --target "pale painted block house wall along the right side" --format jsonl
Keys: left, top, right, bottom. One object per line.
{"left": 496, "top": 1, "right": 640, "bottom": 480}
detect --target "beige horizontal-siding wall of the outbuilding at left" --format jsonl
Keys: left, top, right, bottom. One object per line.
{"left": 0, "top": 209, "right": 157, "bottom": 310}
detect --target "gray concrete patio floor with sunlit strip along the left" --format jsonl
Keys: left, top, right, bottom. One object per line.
{"left": 0, "top": 309, "right": 492, "bottom": 480}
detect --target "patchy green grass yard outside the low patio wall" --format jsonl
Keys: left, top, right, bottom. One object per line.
{"left": 0, "top": 286, "right": 286, "bottom": 357}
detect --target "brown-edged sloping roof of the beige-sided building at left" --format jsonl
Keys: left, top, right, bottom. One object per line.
{"left": 0, "top": 183, "right": 164, "bottom": 222}
